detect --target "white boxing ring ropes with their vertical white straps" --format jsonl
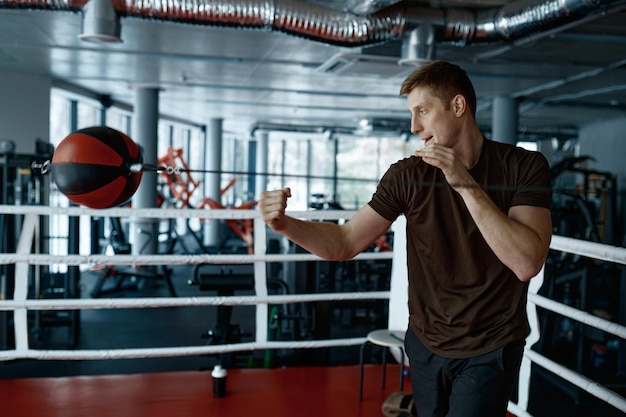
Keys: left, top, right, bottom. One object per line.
{"left": 0, "top": 206, "right": 626, "bottom": 416}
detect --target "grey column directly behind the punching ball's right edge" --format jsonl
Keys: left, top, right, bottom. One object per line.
{"left": 131, "top": 87, "right": 159, "bottom": 255}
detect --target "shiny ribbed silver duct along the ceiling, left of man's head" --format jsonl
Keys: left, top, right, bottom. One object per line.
{"left": 116, "top": 0, "right": 406, "bottom": 47}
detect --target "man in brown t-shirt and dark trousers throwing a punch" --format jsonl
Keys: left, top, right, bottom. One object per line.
{"left": 259, "top": 61, "right": 552, "bottom": 417}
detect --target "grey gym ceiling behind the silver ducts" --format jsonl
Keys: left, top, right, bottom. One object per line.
{"left": 0, "top": 0, "right": 626, "bottom": 137}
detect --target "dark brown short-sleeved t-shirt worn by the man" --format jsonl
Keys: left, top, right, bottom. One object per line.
{"left": 369, "top": 139, "right": 552, "bottom": 358}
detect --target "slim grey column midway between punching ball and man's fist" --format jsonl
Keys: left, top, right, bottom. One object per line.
{"left": 204, "top": 119, "right": 223, "bottom": 247}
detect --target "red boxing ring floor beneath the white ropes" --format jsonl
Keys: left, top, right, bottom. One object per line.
{"left": 0, "top": 364, "right": 410, "bottom": 417}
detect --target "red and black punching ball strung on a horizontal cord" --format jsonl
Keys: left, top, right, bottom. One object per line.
{"left": 51, "top": 126, "right": 143, "bottom": 209}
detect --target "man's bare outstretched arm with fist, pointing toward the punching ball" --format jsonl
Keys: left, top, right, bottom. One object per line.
{"left": 258, "top": 188, "right": 391, "bottom": 260}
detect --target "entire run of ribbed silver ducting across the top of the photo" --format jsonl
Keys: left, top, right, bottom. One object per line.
{"left": 0, "top": 0, "right": 626, "bottom": 46}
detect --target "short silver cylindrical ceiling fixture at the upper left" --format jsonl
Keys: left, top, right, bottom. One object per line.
{"left": 78, "top": 0, "right": 122, "bottom": 43}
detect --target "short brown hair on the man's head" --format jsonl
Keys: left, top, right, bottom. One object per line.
{"left": 400, "top": 61, "right": 476, "bottom": 117}
